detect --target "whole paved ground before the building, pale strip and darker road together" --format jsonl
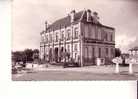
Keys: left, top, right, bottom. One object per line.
{"left": 12, "top": 65, "right": 138, "bottom": 81}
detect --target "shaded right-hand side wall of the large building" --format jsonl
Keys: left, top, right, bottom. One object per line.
{"left": 81, "top": 23, "right": 115, "bottom": 65}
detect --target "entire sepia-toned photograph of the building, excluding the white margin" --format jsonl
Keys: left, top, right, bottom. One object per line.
{"left": 11, "top": 0, "right": 138, "bottom": 81}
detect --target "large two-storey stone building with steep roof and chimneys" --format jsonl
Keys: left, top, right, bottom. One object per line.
{"left": 40, "top": 9, "right": 115, "bottom": 66}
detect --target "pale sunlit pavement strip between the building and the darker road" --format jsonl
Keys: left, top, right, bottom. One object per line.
{"left": 14, "top": 64, "right": 138, "bottom": 74}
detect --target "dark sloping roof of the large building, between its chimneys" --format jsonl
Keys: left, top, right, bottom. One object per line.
{"left": 47, "top": 10, "right": 114, "bottom": 31}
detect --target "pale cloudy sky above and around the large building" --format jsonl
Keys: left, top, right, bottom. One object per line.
{"left": 12, "top": 0, "right": 138, "bottom": 52}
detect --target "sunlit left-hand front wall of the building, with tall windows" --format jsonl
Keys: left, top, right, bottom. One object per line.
{"left": 41, "top": 24, "right": 80, "bottom": 62}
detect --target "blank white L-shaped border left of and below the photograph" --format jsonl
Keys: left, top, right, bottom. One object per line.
{"left": 0, "top": 1, "right": 137, "bottom": 99}
